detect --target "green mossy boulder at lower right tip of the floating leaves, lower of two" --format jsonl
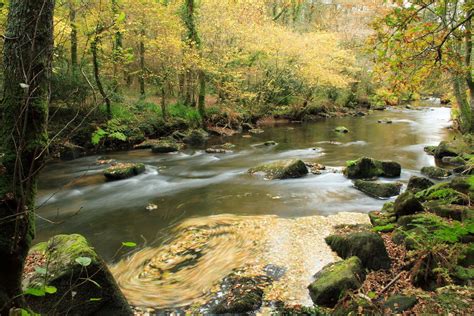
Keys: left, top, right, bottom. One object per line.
{"left": 308, "top": 257, "right": 365, "bottom": 307}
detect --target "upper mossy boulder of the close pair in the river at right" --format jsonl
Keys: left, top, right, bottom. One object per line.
{"left": 344, "top": 157, "right": 402, "bottom": 179}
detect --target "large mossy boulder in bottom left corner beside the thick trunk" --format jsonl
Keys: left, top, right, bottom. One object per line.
{"left": 23, "top": 235, "right": 133, "bottom": 315}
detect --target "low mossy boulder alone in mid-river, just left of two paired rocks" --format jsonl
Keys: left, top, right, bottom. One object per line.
{"left": 248, "top": 159, "right": 308, "bottom": 179}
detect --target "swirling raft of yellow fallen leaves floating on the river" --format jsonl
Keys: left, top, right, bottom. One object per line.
{"left": 111, "top": 213, "right": 368, "bottom": 308}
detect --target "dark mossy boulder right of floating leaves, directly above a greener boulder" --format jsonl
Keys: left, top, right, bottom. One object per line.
{"left": 325, "top": 231, "right": 390, "bottom": 270}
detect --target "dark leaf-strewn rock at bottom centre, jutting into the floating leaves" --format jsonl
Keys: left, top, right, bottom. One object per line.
{"left": 210, "top": 274, "right": 269, "bottom": 314}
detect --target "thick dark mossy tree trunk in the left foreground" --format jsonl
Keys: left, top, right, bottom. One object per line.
{"left": 0, "top": 0, "right": 54, "bottom": 315}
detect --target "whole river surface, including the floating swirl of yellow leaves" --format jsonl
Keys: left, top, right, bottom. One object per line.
{"left": 38, "top": 103, "right": 450, "bottom": 308}
